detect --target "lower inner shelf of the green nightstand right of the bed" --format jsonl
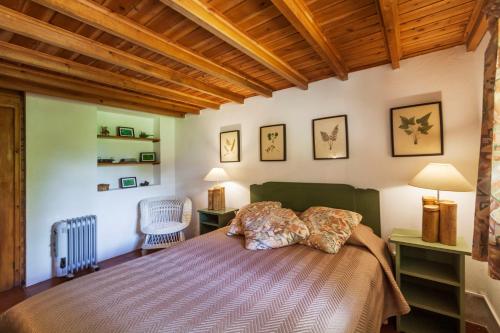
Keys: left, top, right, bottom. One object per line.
{"left": 401, "top": 280, "right": 460, "bottom": 319}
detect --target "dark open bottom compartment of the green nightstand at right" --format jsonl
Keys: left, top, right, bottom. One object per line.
{"left": 401, "top": 309, "right": 458, "bottom": 333}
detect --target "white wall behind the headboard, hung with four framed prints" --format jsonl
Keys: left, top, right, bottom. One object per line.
{"left": 176, "top": 43, "right": 500, "bottom": 311}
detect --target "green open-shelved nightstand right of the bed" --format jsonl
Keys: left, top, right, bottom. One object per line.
{"left": 389, "top": 229, "right": 471, "bottom": 333}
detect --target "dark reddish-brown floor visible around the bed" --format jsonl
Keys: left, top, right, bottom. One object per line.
{"left": 0, "top": 250, "right": 488, "bottom": 333}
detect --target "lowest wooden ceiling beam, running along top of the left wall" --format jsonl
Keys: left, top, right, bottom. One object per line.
{"left": 0, "top": 77, "right": 185, "bottom": 118}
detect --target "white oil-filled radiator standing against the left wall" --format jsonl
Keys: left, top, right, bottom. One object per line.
{"left": 52, "top": 215, "right": 99, "bottom": 278}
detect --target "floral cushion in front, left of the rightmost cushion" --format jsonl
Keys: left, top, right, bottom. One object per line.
{"left": 242, "top": 208, "right": 309, "bottom": 250}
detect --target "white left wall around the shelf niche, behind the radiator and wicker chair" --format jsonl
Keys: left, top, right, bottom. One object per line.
{"left": 26, "top": 94, "right": 175, "bottom": 285}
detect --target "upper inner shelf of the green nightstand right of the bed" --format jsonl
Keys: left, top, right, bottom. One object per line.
{"left": 400, "top": 257, "right": 460, "bottom": 287}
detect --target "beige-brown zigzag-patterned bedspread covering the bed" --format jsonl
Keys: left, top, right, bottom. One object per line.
{"left": 0, "top": 230, "right": 409, "bottom": 333}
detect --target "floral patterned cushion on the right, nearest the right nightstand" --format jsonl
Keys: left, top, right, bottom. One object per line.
{"left": 300, "top": 207, "right": 362, "bottom": 253}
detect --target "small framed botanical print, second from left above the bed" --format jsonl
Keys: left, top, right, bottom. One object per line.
{"left": 260, "top": 124, "right": 286, "bottom": 161}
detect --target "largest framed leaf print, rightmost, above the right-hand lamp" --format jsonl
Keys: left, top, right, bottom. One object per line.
{"left": 391, "top": 102, "right": 444, "bottom": 157}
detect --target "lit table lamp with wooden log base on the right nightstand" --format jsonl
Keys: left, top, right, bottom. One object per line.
{"left": 408, "top": 163, "right": 474, "bottom": 246}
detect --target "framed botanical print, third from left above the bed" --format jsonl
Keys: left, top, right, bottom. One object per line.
{"left": 312, "top": 115, "right": 349, "bottom": 160}
